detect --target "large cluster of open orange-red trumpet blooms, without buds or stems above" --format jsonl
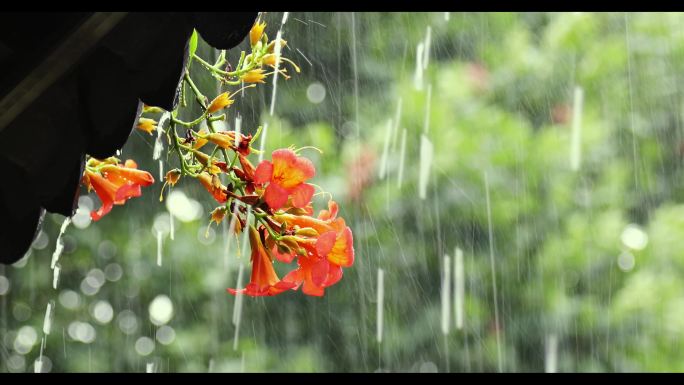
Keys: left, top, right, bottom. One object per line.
{"left": 228, "top": 149, "right": 354, "bottom": 296}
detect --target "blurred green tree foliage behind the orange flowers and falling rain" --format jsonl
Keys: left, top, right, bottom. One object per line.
{"left": 0, "top": 12, "right": 684, "bottom": 372}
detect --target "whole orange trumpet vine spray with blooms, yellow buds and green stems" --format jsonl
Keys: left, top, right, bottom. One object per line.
{"left": 83, "top": 15, "right": 354, "bottom": 296}
